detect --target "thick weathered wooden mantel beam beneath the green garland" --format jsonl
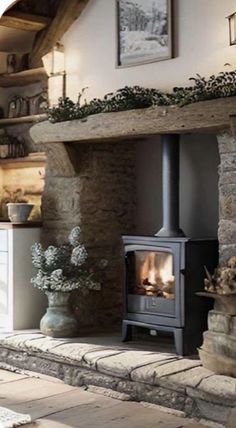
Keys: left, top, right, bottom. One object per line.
{"left": 30, "top": 97, "right": 236, "bottom": 143}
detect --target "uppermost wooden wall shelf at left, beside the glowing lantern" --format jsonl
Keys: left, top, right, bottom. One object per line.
{"left": 0, "top": 67, "right": 47, "bottom": 88}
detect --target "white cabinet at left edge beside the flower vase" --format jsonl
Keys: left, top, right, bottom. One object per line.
{"left": 0, "top": 227, "right": 46, "bottom": 331}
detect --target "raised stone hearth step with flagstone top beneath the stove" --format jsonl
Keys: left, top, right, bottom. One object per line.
{"left": 0, "top": 332, "right": 236, "bottom": 425}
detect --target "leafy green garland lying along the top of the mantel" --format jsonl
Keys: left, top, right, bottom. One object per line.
{"left": 48, "top": 70, "right": 236, "bottom": 123}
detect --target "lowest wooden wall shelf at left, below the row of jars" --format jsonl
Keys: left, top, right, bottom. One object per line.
{"left": 0, "top": 152, "right": 46, "bottom": 169}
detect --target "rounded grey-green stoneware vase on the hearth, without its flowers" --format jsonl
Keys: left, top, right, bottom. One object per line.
{"left": 40, "top": 291, "right": 78, "bottom": 337}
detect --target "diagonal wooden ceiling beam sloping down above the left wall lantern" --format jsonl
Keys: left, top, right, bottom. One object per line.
{"left": 30, "top": 0, "right": 89, "bottom": 67}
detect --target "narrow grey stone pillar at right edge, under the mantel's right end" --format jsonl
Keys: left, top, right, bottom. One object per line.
{"left": 217, "top": 131, "right": 236, "bottom": 264}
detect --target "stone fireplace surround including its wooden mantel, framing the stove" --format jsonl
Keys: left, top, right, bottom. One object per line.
{"left": 30, "top": 97, "right": 236, "bottom": 330}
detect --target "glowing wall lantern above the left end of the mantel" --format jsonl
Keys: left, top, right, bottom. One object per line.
{"left": 42, "top": 43, "right": 66, "bottom": 107}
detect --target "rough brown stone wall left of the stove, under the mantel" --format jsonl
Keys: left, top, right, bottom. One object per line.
{"left": 42, "top": 142, "right": 136, "bottom": 329}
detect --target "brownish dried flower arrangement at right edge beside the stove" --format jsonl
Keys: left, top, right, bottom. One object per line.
{"left": 204, "top": 256, "right": 236, "bottom": 296}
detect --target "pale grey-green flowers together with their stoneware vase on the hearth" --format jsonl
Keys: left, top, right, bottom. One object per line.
{"left": 31, "top": 227, "right": 101, "bottom": 337}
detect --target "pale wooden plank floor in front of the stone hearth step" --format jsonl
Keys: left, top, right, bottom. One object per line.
{"left": 0, "top": 370, "right": 206, "bottom": 428}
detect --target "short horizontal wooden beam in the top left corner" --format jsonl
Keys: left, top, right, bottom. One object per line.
{"left": 0, "top": 11, "right": 51, "bottom": 32}
